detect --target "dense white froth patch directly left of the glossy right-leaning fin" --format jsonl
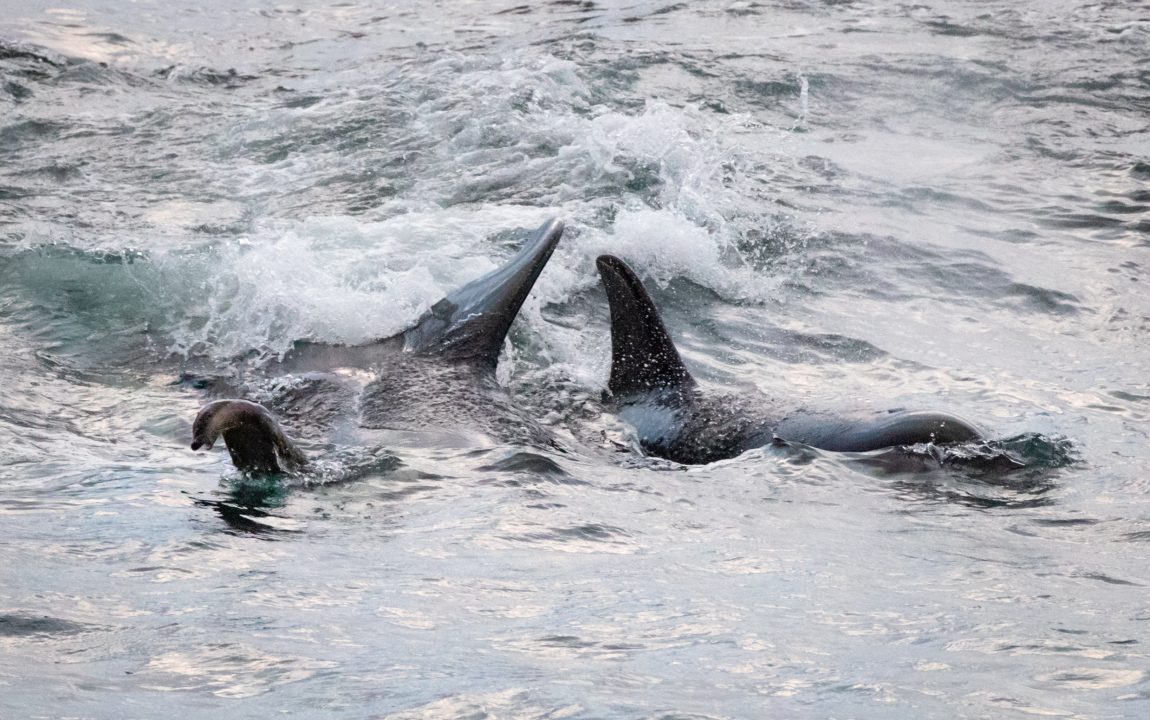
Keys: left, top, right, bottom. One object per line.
{"left": 167, "top": 206, "right": 561, "bottom": 358}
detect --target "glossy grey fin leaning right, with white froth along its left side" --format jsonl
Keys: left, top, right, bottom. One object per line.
{"left": 404, "top": 219, "right": 564, "bottom": 368}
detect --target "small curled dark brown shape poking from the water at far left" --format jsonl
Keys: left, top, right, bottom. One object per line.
{"left": 192, "top": 400, "right": 307, "bottom": 473}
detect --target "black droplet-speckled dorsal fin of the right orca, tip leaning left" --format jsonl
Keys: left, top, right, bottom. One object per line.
{"left": 595, "top": 255, "right": 695, "bottom": 396}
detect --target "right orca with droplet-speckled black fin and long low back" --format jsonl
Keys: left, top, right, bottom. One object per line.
{"left": 596, "top": 255, "right": 982, "bottom": 465}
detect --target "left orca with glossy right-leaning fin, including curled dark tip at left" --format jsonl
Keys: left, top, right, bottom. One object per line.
{"left": 192, "top": 220, "right": 564, "bottom": 473}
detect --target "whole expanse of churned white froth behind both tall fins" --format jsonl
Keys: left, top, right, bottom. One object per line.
{"left": 173, "top": 51, "right": 800, "bottom": 359}
